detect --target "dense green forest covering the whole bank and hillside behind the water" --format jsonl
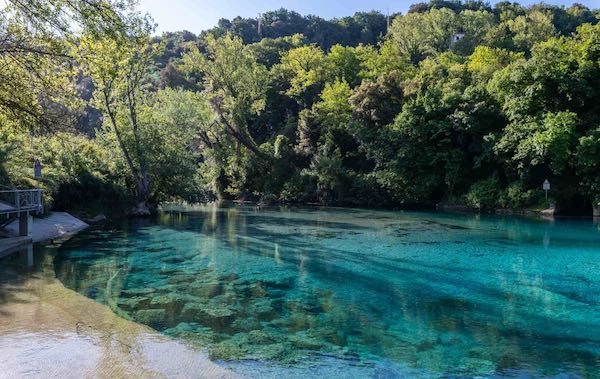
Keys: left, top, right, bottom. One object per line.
{"left": 0, "top": 0, "right": 600, "bottom": 215}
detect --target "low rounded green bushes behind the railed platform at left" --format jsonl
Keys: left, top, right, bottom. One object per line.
{"left": 0, "top": 126, "right": 127, "bottom": 208}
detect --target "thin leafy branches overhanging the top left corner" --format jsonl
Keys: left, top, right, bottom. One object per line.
{"left": 0, "top": 0, "right": 137, "bottom": 129}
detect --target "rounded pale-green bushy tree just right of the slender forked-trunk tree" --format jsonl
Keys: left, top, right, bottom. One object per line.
{"left": 127, "top": 89, "right": 214, "bottom": 202}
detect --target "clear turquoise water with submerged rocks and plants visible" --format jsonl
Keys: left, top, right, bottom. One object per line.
{"left": 48, "top": 206, "right": 600, "bottom": 378}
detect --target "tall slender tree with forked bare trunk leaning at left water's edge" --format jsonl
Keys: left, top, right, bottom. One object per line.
{"left": 75, "top": 20, "right": 155, "bottom": 215}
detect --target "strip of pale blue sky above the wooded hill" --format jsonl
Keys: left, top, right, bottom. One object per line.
{"left": 139, "top": 0, "right": 600, "bottom": 34}
